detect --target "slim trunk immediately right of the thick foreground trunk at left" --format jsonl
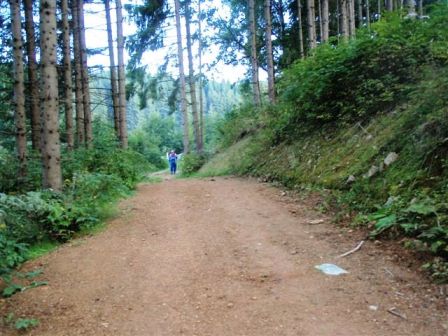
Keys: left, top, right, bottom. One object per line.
{"left": 61, "top": 0, "right": 75, "bottom": 150}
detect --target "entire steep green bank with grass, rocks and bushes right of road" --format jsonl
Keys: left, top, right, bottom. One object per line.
{"left": 200, "top": 6, "right": 448, "bottom": 280}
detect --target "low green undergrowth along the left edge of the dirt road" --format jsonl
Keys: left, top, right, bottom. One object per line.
{"left": 0, "top": 144, "right": 154, "bottom": 284}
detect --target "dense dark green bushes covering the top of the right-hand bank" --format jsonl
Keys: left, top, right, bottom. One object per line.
{"left": 271, "top": 7, "right": 448, "bottom": 140}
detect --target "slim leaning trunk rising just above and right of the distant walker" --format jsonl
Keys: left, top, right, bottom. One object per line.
{"left": 174, "top": 0, "right": 190, "bottom": 154}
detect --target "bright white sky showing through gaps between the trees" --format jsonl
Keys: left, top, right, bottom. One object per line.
{"left": 85, "top": 0, "right": 252, "bottom": 83}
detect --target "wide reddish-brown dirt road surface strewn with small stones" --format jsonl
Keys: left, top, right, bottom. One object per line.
{"left": 0, "top": 178, "right": 448, "bottom": 336}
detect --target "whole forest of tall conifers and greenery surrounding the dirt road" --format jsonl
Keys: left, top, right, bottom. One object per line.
{"left": 0, "top": 0, "right": 448, "bottom": 329}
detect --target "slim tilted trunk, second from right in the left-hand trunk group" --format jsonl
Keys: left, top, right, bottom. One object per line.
{"left": 104, "top": 0, "right": 121, "bottom": 139}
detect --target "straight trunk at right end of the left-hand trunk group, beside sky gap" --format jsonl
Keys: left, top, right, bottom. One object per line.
{"left": 116, "top": 0, "right": 128, "bottom": 149}
